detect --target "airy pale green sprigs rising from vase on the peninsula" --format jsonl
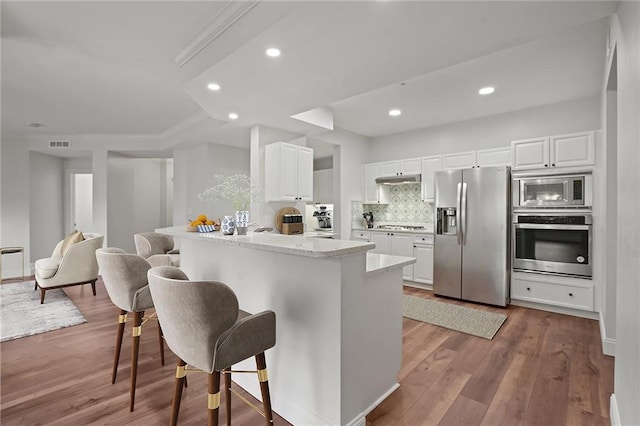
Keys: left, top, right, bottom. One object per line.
{"left": 198, "top": 174, "right": 262, "bottom": 211}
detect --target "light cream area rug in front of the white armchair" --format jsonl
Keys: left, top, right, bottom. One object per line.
{"left": 0, "top": 281, "right": 87, "bottom": 342}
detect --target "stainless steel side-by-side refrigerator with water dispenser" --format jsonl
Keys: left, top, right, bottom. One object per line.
{"left": 433, "top": 167, "right": 511, "bottom": 306}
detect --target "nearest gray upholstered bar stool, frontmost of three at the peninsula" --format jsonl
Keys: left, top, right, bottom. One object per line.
{"left": 148, "top": 266, "right": 276, "bottom": 426}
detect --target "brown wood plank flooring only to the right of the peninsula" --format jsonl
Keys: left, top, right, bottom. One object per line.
{"left": 367, "top": 287, "right": 614, "bottom": 426}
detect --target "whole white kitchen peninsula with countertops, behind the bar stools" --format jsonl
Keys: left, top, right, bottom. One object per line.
{"left": 157, "top": 227, "right": 415, "bottom": 425}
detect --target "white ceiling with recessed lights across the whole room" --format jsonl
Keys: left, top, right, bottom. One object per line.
{"left": 1, "top": 1, "right": 617, "bottom": 157}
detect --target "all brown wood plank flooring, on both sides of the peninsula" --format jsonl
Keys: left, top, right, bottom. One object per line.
{"left": 0, "top": 280, "right": 613, "bottom": 426}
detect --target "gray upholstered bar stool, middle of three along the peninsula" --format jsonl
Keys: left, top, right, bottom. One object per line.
{"left": 96, "top": 247, "right": 171, "bottom": 411}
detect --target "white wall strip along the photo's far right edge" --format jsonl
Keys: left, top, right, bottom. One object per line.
{"left": 611, "top": 1, "right": 640, "bottom": 425}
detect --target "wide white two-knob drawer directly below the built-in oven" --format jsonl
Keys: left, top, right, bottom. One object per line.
{"left": 511, "top": 273, "right": 595, "bottom": 312}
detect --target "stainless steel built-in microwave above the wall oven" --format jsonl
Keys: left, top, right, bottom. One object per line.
{"left": 511, "top": 173, "right": 593, "bottom": 209}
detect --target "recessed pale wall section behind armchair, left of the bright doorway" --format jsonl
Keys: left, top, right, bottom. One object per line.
{"left": 29, "top": 151, "right": 64, "bottom": 262}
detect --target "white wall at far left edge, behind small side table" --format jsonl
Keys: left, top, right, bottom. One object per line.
{"left": 0, "top": 132, "right": 31, "bottom": 277}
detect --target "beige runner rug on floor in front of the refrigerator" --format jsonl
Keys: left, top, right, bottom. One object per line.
{"left": 402, "top": 294, "right": 507, "bottom": 340}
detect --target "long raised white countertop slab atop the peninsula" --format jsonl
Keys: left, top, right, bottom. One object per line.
{"left": 156, "top": 226, "right": 375, "bottom": 258}
